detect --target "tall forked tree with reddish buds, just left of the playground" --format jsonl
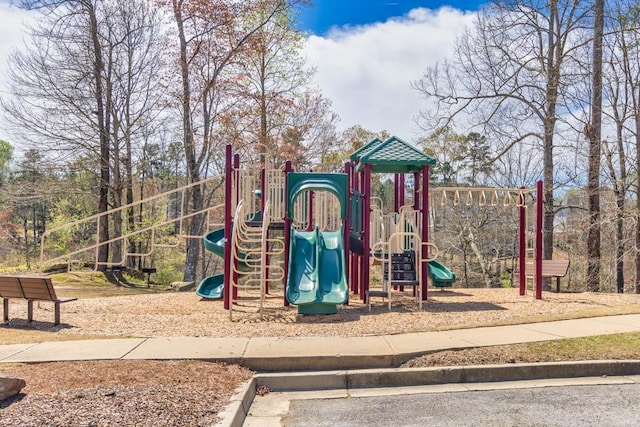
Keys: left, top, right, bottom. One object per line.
{"left": 167, "top": 0, "right": 287, "bottom": 281}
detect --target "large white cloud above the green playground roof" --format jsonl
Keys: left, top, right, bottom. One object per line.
{"left": 306, "top": 7, "right": 474, "bottom": 141}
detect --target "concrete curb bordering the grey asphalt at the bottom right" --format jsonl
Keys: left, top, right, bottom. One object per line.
{"left": 217, "top": 360, "right": 640, "bottom": 427}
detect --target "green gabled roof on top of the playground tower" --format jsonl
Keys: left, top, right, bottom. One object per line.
{"left": 354, "top": 136, "right": 436, "bottom": 173}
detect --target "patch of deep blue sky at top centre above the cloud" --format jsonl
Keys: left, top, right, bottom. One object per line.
{"left": 299, "top": 0, "right": 485, "bottom": 35}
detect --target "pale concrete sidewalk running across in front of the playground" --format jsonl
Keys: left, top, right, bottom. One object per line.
{"left": 0, "top": 314, "right": 640, "bottom": 371}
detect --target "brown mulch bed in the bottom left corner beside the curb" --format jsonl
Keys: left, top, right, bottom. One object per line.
{"left": 0, "top": 361, "right": 251, "bottom": 427}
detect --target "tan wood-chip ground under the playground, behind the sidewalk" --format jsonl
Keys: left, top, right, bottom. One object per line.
{"left": 9, "top": 289, "right": 640, "bottom": 337}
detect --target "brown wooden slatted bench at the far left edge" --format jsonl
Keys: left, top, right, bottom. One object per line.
{"left": 0, "top": 276, "right": 77, "bottom": 325}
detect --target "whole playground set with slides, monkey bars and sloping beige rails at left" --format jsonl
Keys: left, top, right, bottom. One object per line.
{"left": 36, "top": 137, "right": 542, "bottom": 316}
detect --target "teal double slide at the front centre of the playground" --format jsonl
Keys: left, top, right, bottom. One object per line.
{"left": 287, "top": 226, "right": 348, "bottom": 314}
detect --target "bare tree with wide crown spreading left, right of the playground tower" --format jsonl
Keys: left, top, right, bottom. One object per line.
{"left": 413, "top": 0, "right": 591, "bottom": 259}
